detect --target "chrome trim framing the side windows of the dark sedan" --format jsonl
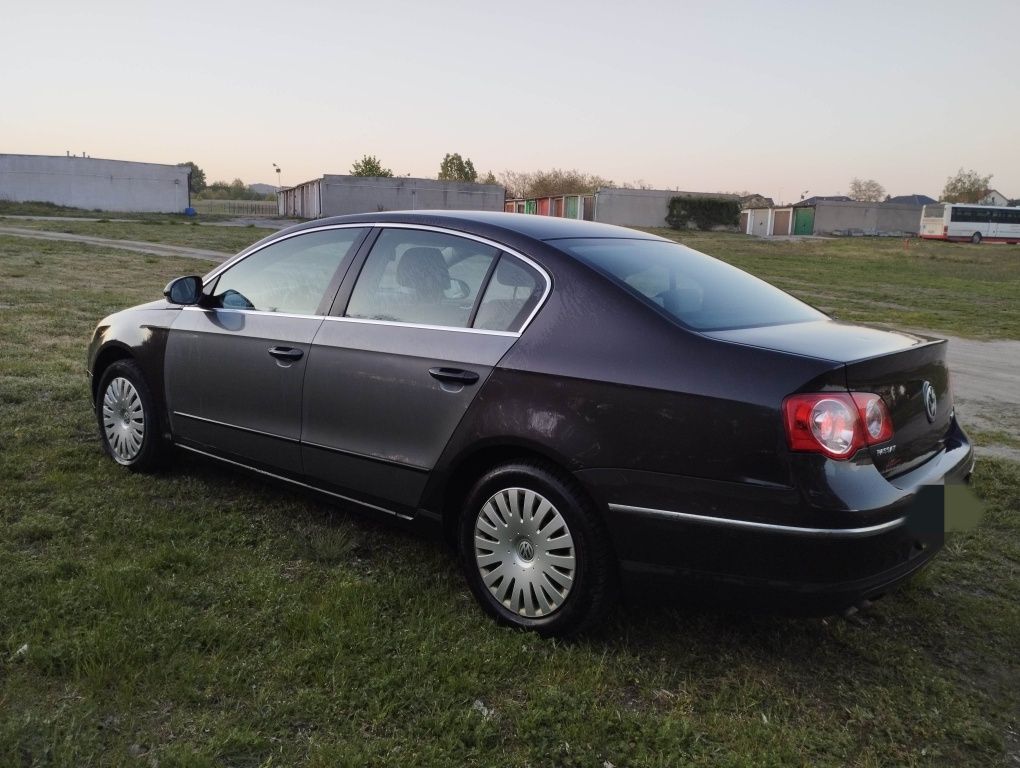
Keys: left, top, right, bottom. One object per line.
{"left": 196, "top": 221, "right": 553, "bottom": 338}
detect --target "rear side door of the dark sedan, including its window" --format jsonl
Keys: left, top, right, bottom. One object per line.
{"left": 301, "top": 227, "right": 548, "bottom": 508}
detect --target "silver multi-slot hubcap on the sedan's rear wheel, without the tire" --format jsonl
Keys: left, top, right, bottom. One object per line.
{"left": 474, "top": 488, "right": 577, "bottom": 618}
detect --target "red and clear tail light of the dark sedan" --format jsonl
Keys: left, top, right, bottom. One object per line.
{"left": 782, "top": 392, "right": 893, "bottom": 459}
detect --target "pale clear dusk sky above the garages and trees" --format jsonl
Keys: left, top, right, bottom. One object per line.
{"left": 0, "top": 0, "right": 1020, "bottom": 202}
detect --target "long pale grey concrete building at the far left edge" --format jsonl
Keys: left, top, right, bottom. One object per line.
{"left": 0, "top": 155, "right": 189, "bottom": 213}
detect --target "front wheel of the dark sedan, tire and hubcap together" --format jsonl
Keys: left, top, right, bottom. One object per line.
{"left": 94, "top": 360, "right": 169, "bottom": 472}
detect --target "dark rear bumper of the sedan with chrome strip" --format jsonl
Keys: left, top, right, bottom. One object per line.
{"left": 578, "top": 428, "right": 974, "bottom": 613}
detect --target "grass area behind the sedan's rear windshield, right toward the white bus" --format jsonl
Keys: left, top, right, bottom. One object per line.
{"left": 649, "top": 229, "right": 1020, "bottom": 339}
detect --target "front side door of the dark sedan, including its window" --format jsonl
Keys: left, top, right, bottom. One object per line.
{"left": 165, "top": 227, "right": 367, "bottom": 473}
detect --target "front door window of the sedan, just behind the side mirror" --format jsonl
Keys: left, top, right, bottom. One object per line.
{"left": 210, "top": 227, "right": 365, "bottom": 314}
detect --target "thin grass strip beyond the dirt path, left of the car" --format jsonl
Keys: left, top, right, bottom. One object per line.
{"left": 0, "top": 216, "right": 275, "bottom": 255}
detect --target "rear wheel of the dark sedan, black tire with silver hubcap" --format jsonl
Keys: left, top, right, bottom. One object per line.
{"left": 458, "top": 461, "right": 618, "bottom": 636}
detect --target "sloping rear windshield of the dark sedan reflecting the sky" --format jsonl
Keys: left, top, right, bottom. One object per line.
{"left": 549, "top": 239, "right": 825, "bottom": 330}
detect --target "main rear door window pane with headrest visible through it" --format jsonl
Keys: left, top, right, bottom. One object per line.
{"left": 347, "top": 228, "right": 500, "bottom": 328}
